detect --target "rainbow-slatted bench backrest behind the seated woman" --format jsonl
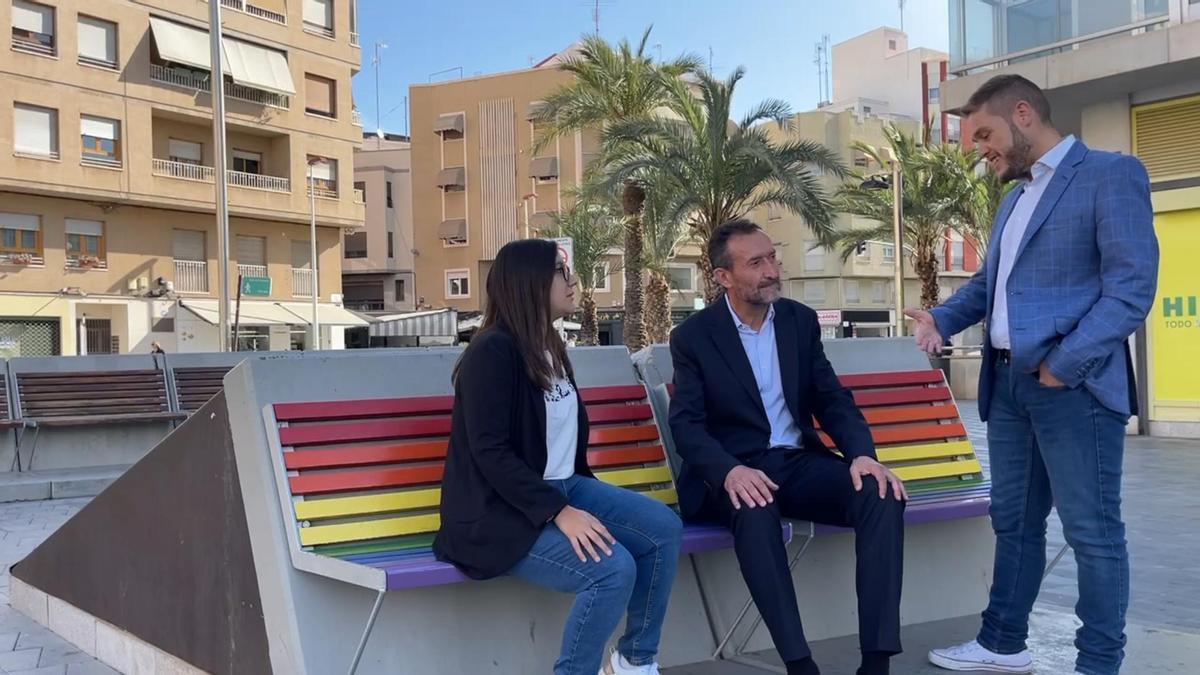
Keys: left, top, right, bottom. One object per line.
{"left": 271, "top": 384, "right": 677, "bottom": 557}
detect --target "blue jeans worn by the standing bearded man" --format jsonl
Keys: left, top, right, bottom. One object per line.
{"left": 979, "top": 364, "right": 1129, "bottom": 675}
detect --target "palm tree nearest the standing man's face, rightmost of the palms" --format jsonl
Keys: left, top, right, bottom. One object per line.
{"left": 836, "top": 125, "right": 964, "bottom": 309}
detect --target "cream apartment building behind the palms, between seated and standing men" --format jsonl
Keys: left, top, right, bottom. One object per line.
{"left": 754, "top": 108, "right": 979, "bottom": 338}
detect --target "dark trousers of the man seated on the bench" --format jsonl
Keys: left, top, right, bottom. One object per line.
{"left": 701, "top": 448, "right": 905, "bottom": 661}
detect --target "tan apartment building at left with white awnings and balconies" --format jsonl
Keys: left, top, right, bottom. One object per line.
{"left": 0, "top": 0, "right": 364, "bottom": 356}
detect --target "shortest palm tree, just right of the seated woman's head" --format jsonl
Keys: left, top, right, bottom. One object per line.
{"left": 539, "top": 199, "right": 623, "bottom": 345}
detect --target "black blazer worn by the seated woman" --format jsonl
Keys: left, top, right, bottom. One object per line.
{"left": 433, "top": 328, "right": 593, "bottom": 579}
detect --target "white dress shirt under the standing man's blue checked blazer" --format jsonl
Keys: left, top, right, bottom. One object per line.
{"left": 988, "top": 136, "right": 1075, "bottom": 350}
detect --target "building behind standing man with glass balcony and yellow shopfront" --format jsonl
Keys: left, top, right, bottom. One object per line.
{"left": 942, "top": 0, "right": 1200, "bottom": 437}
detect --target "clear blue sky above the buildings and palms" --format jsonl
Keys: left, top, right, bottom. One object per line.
{"left": 354, "top": 0, "right": 949, "bottom": 133}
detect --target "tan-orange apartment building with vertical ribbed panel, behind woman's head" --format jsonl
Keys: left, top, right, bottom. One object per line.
{"left": 409, "top": 50, "right": 703, "bottom": 344}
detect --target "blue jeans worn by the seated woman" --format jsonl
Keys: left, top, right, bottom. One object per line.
{"left": 509, "top": 476, "right": 683, "bottom": 675}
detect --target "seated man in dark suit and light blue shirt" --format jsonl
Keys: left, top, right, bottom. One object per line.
{"left": 671, "top": 220, "right": 907, "bottom": 675}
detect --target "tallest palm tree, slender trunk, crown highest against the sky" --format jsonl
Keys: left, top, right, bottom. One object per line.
{"left": 534, "top": 28, "right": 701, "bottom": 351}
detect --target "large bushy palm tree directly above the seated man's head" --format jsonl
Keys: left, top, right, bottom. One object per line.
{"left": 605, "top": 67, "right": 845, "bottom": 301}
